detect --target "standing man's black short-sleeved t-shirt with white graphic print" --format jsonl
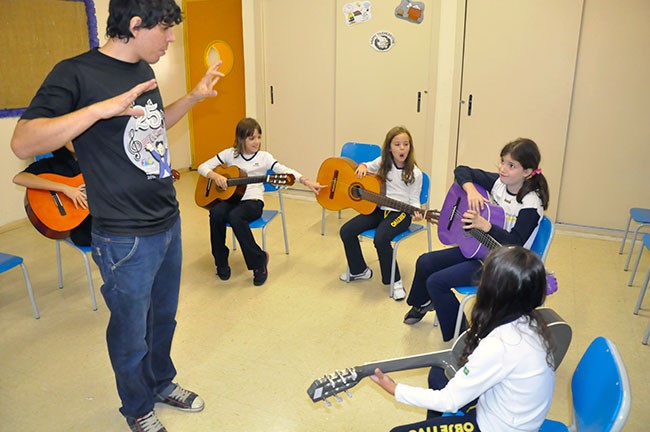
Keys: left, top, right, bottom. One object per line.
{"left": 22, "top": 49, "right": 179, "bottom": 235}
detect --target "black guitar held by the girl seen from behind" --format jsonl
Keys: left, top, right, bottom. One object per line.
{"left": 307, "top": 308, "right": 573, "bottom": 406}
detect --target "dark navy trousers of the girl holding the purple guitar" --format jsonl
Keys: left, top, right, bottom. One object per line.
{"left": 406, "top": 247, "right": 482, "bottom": 341}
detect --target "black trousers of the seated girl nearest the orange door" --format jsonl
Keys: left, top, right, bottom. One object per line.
{"left": 210, "top": 200, "right": 266, "bottom": 270}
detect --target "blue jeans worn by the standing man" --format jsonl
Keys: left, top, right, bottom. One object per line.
{"left": 92, "top": 218, "right": 182, "bottom": 418}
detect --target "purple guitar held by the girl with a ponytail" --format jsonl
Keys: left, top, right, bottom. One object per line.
{"left": 438, "top": 182, "right": 557, "bottom": 294}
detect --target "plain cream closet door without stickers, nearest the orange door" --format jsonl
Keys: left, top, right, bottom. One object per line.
{"left": 263, "top": 0, "right": 335, "bottom": 179}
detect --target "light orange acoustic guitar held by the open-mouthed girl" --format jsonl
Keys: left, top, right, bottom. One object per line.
{"left": 316, "top": 157, "right": 439, "bottom": 223}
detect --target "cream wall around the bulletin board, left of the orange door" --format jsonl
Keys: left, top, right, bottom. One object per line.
{"left": 0, "top": 0, "right": 190, "bottom": 228}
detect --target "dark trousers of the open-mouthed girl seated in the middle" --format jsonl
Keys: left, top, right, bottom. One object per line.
{"left": 340, "top": 208, "right": 411, "bottom": 285}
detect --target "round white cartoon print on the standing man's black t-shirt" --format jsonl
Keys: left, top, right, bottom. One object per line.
{"left": 124, "top": 99, "right": 172, "bottom": 179}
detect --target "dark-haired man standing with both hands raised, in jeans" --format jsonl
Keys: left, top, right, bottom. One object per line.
{"left": 11, "top": 0, "right": 223, "bottom": 432}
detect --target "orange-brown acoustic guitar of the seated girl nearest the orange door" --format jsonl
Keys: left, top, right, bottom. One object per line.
{"left": 194, "top": 165, "right": 296, "bottom": 209}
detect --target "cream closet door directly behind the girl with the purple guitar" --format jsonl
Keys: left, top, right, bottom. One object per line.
{"left": 456, "top": 0, "right": 583, "bottom": 219}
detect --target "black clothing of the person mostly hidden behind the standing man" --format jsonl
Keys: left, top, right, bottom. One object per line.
{"left": 23, "top": 147, "right": 92, "bottom": 246}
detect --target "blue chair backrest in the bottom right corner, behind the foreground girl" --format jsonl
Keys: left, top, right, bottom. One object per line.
{"left": 571, "top": 337, "right": 632, "bottom": 432}
